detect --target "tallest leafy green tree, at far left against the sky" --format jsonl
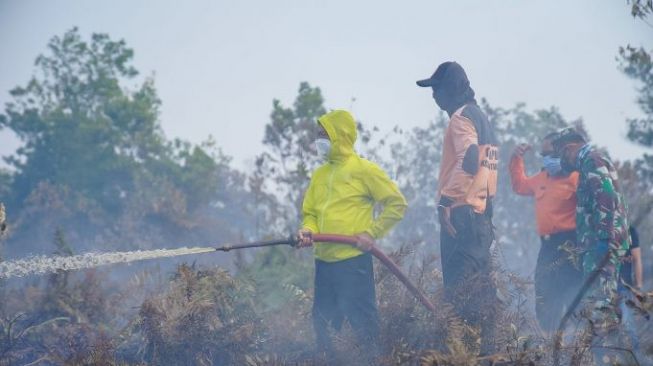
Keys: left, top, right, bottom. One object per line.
{"left": 0, "top": 28, "right": 165, "bottom": 209}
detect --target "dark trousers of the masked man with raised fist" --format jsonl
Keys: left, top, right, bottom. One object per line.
{"left": 535, "top": 230, "right": 583, "bottom": 332}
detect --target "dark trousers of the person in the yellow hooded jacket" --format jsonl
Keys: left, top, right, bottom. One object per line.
{"left": 313, "top": 254, "right": 379, "bottom": 357}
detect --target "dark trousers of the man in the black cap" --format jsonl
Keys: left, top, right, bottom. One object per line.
{"left": 440, "top": 206, "right": 499, "bottom": 353}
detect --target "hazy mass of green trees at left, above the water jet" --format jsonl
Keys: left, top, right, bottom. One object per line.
{"left": 0, "top": 28, "right": 255, "bottom": 255}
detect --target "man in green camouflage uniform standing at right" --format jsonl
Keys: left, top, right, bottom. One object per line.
{"left": 553, "top": 128, "right": 630, "bottom": 362}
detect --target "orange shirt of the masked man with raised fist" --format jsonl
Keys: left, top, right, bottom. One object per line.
{"left": 510, "top": 155, "right": 578, "bottom": 235}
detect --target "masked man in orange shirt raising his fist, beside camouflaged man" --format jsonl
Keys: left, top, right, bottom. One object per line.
{"left": 510, "top": 133, "right": 583, "bottom": 332}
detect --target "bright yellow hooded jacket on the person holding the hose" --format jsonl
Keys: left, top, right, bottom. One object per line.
{"left": 303, "top": 110, "right": 406, "bottom": 262}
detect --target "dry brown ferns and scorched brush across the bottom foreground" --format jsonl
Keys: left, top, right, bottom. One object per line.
{"left": 0, "top": 240, "right": 653, "bottom": 366}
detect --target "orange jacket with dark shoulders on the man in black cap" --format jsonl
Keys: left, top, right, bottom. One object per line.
{"left": 439, "top": 104, "right": 498, "bottom": 213}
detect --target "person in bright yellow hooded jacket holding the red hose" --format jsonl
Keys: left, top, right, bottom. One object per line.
{"left": 298, "top": 110, "right": 407, "bottom": 356}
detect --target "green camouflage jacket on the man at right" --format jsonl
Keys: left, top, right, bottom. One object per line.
{"left": 576, "top": 146, "right": 630, "bottom": 274}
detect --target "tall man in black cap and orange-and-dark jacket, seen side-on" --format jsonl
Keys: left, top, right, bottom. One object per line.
{"left": 417, "top": 61, "right": 500, "bottom": 354}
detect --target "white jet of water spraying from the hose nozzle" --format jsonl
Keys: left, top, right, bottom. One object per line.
{"left": 0, "top": 247, "right": 215, "bottom": 279}
